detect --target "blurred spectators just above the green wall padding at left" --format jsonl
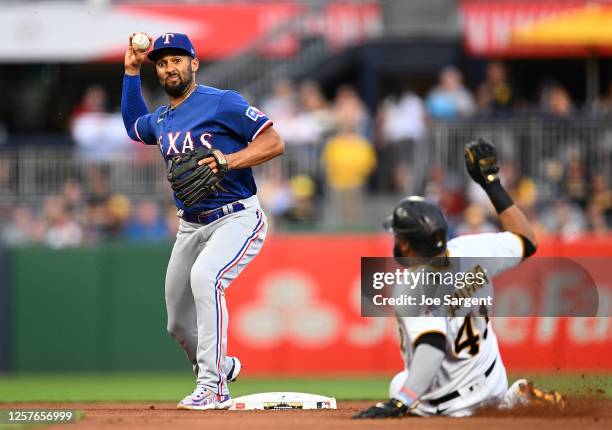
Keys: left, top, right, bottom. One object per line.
{"left": 1, "top": 176, "right": 178, "bottom": 248}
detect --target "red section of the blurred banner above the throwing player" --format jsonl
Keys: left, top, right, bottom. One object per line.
{"left": 112, "top": 1, "right": 381, "bottom": 59}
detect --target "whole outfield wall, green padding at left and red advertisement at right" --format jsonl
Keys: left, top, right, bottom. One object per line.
{"left": 5, "top": 235, "right": 612, "bottom": 375}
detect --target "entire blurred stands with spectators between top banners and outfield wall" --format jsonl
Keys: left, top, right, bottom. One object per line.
{"left": 0, "top": 0, "right": 612, "bottom": 248}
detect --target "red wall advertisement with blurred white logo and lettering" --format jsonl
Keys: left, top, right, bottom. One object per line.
{"left": 226, "top": 235, "right": 612, "bottom": 374}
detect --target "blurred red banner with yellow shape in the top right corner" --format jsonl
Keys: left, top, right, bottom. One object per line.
{"left": 461, "top": 0, "right": 612, "bottom": 57}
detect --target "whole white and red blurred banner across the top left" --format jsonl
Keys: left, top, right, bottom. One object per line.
{"left": 0, "top": 1, "right": 382, "bottom": 62}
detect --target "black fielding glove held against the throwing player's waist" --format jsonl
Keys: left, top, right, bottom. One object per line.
{"left": 168, "top": 147, "right": 228, "bottom": 207}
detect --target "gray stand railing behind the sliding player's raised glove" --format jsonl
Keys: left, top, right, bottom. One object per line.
{"left": 428, "top": 119, "right": 612, "bottom": 198}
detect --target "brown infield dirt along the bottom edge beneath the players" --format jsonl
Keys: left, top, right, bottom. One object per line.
{"left": 0, "top": 399, "right": 612, "bottom": 430}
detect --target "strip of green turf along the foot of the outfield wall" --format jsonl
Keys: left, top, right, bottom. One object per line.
{"left": 0, "top": 373, "right": 612, "bottom": 402}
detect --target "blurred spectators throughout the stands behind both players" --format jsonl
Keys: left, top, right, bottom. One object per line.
{"left": 0, "top": 62, "right": 612, "bottom": 248}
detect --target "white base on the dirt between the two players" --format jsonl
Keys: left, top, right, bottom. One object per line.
{"left": 230, "top": 392, "right": 337, "bottom": 411}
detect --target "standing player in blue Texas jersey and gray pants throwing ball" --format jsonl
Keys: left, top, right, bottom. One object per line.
{"left": 121, "top": 33, "right": 284, "bottom": 410}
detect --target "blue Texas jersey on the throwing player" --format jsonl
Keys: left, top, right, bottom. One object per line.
{"left": 128, "top": 85, "right": 272, "bottom": 213}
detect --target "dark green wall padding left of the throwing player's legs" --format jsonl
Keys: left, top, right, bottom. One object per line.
{"left": 9, "top": 244, "right": 185, "bottom": 371}
